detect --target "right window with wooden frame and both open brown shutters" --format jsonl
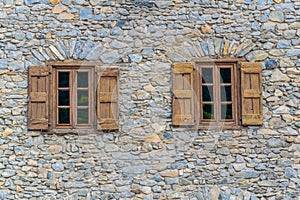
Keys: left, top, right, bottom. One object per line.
{"left": 172, "top": 60, "right": 262, "bottom": 129}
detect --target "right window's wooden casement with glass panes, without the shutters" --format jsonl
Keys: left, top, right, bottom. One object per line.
{"left": 195, "top": 62, "right": 238, "bottom": 127}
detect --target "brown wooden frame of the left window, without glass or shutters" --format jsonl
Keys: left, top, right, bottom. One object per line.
{"left": 49, "top": 64, "right": 96, "bottom": 133}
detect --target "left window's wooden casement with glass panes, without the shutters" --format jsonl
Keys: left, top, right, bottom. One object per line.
{"left": 53, "top": 67, "right": 95, "bottom": 129}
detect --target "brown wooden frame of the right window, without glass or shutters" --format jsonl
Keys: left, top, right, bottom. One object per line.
{"left": 194, "top": 60, "right": 241, "bottom": 129}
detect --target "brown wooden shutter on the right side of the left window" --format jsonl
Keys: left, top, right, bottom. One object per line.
{"left": 97, "top": 68, "right": 119, "bottom": 130}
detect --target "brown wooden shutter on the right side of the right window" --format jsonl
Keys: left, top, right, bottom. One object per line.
{"left": 241, "top": 62, "right": 263, "bottom": 125}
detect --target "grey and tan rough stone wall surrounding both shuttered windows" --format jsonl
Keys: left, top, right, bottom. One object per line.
{"left": 0, "top": 0, "right": 300, "bottom": 200}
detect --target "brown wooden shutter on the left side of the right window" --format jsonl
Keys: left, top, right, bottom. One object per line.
{"left": 172, "top": 63, "right": 195, "bottom": 126}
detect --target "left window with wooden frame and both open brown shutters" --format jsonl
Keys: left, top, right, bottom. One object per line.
{"left": 28, "top": 64, "right": 119, "bottom": 133}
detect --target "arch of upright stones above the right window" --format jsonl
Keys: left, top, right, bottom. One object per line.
{"left": 165, "top": 38, "right": 256, "bottom": 62}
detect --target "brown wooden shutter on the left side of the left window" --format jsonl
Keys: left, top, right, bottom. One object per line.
{"left": 28, "top": 66, "right": 49, "bottom": 130}
